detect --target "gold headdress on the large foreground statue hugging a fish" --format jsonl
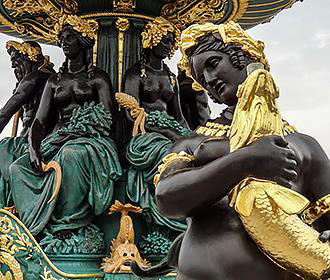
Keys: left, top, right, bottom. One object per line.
{"left": 179, "top": 21, "right": 269, "bottom": 90}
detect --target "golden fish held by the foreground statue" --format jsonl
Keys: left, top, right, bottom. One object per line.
{"left": 229, "top": 70, "right": 330, "bottom": 279}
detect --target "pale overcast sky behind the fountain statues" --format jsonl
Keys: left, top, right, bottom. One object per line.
{"left": 0, "top": 0, "right": 330, "bottom": 155}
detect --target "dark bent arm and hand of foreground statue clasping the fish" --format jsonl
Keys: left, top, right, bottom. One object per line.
{"left": 156, "top": 136, "right": 294, "bottom": 218}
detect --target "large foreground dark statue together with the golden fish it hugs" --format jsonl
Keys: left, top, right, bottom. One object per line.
{"left": 131, "top": 22, "right": 330, "bottom": 280}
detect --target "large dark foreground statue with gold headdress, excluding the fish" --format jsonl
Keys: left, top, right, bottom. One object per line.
{"left": 131, "top": 24, "right": 330, "bottom": 280}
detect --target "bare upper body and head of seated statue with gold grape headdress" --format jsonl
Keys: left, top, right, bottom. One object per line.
{"left": 124, "top": 17, "right": 188, "bottom": 132}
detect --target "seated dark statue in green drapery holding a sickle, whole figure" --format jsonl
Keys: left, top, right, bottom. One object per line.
{"left": 10, "top": 16, "right": 121, "bottom": 236}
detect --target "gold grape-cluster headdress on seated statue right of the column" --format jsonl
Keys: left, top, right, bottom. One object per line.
{"left": 141, "top": 17, "right": 180, "bottom": 58}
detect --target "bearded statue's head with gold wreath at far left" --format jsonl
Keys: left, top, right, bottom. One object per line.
{"left": 6, "top": 40, "right": 53, "bottom": 80}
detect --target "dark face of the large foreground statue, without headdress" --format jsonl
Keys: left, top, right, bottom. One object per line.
{"left": 190, "top": 51, "right": 247, "bottom": 106}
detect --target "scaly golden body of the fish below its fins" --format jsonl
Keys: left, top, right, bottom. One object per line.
{"left": 240, "top": 186, "right": 330, "bottom": 279}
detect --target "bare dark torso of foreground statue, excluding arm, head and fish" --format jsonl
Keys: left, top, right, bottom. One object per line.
{"left": 177, "top": 130, "right": 306, "bottom": 280}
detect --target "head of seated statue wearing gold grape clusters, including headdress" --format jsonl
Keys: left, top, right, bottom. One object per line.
{"left": 142, "top": 17, "right": 180, "bottom": 59}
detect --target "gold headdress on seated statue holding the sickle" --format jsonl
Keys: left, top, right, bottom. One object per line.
{"left": 55, "top": 14, "right": 99, "bottom": 39}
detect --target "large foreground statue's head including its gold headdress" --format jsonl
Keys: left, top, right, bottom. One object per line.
{"left": 179, "top": 22, "right": 269, "bottom": 106}
